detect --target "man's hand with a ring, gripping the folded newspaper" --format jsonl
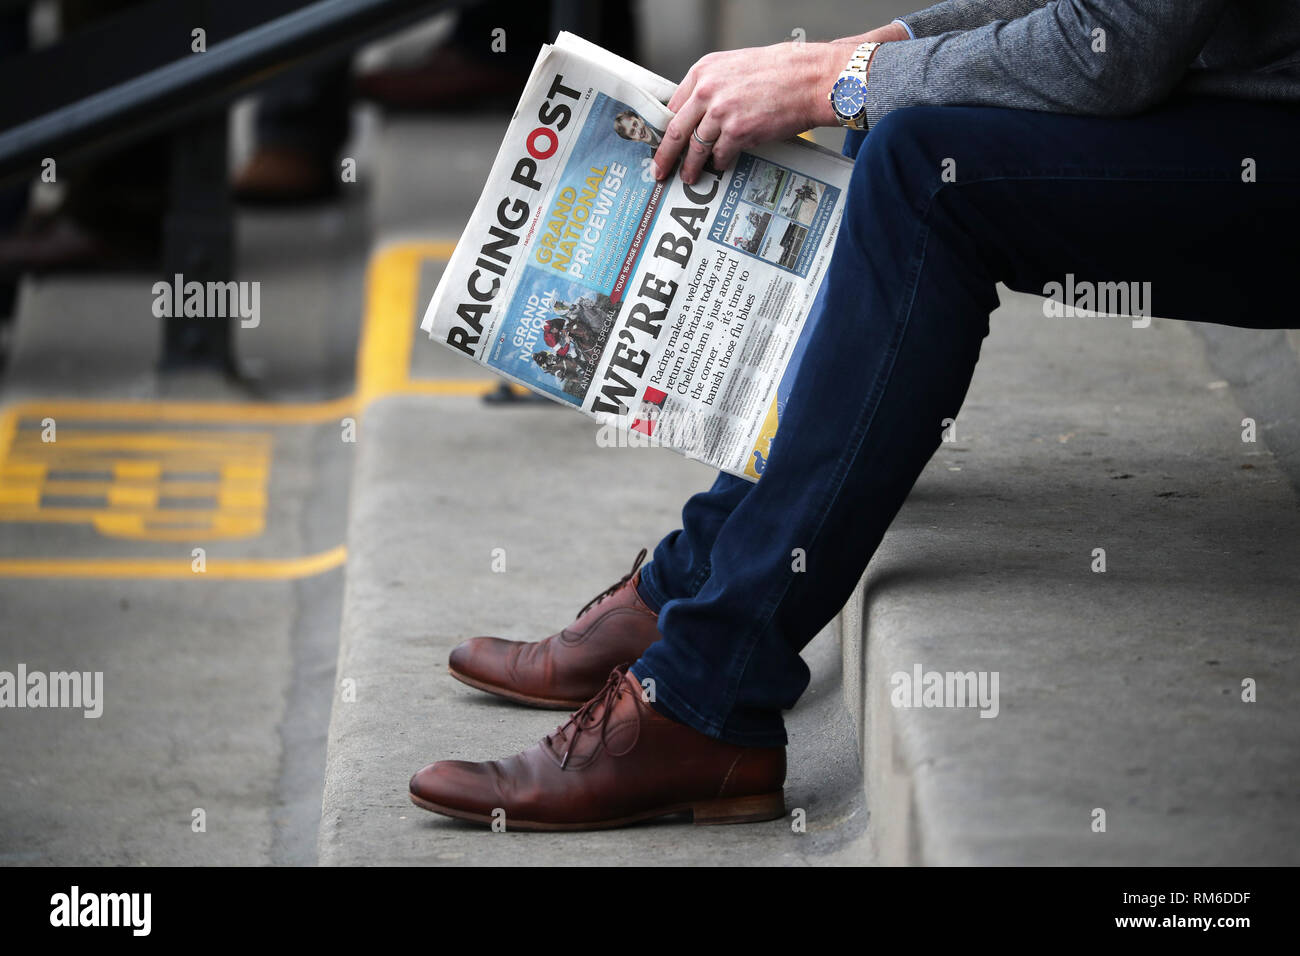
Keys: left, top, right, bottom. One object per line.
{"left": 654, "top": 23, "right": 907, "bottom": 182}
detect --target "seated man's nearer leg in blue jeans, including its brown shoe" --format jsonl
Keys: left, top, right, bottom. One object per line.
{"left": 411, "top": 100, "right": 1300, "bottom": 829}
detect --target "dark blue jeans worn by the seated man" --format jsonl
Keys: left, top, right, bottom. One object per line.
{"left": 633, "top": 99, "right": 1300, "bottom": 747}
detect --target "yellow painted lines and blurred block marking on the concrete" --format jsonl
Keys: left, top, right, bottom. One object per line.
{"left": 0, "top": 241, "right": 496, "bottom": 580}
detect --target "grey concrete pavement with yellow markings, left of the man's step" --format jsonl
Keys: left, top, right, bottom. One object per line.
{"left": 0, "top": 197, "right": 368, "bottom": 866}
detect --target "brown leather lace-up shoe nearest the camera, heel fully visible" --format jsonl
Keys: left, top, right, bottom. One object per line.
{"left": 411, "top": 669, "right": 785, "bottom": 830}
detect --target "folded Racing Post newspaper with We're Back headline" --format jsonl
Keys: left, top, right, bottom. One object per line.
{"left": 420, "top": 33, "right": 853, "bottom": 480}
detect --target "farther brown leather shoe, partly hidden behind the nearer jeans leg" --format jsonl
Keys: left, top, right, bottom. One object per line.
{"left": 447, "top": 548, "right": 659, "bottom": 710}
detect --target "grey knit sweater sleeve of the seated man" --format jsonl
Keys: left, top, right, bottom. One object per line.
{"left": 867, "top": 0, "right": 1300, "bottom": 125}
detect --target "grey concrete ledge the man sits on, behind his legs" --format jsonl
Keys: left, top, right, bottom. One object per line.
{"left": 839, "top": 295, "right": 1300, "bottom": 865}
